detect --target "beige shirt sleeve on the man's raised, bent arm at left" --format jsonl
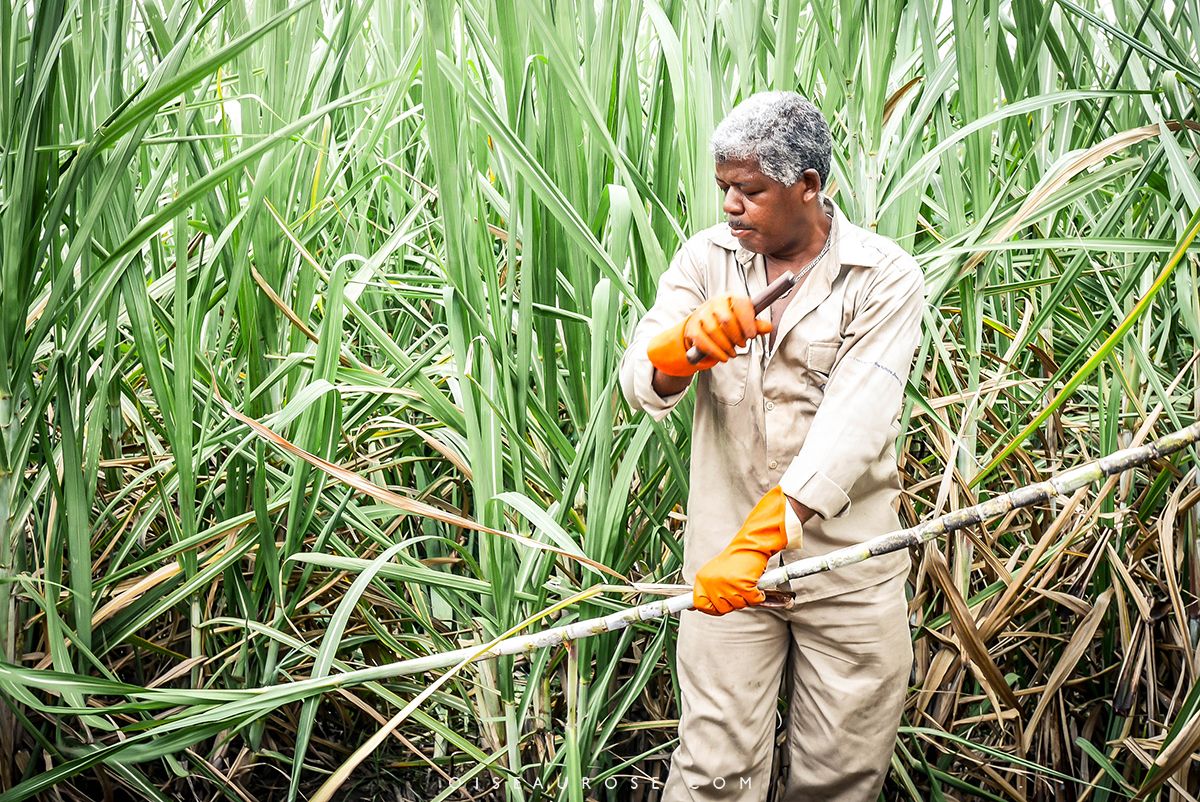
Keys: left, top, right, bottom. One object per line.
{"left": 620, "top": 247, "right": 706, "bottom": 420}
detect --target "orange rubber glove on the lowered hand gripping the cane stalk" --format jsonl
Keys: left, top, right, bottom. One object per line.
{"left": 691, "top": 485, "right": 802, "bottom": 616}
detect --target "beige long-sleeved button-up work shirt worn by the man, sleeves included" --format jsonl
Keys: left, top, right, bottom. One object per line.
{"left": 620, "top": 198, "right": 925, "bottom": 600}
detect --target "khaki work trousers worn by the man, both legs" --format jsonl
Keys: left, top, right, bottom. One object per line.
{"left": 662, "top": 575, "right": 912, "bottom": 802}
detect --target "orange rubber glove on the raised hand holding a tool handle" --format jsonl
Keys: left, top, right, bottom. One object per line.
{"left": 647, "top": 293, "right": 772, "bottom": 377}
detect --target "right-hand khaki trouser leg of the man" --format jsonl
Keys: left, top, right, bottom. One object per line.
{"left": 787, "top": 575, "right": 912, "bottom": 802}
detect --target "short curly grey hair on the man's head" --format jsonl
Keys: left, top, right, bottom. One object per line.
{"left": 713, "top": 91, "right": 832, "bottom": 187}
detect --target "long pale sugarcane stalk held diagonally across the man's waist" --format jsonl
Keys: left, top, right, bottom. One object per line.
{"left": 343, "top": 421, "right": 1200, "bottom": 678}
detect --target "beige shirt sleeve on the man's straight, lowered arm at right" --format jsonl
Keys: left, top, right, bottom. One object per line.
{"left": 779, "top": 253, "right": 925, "bottom": 520}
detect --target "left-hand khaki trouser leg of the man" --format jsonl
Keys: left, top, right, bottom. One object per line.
{"left": 662, "top": 609, "right": 790, "bottom": 802}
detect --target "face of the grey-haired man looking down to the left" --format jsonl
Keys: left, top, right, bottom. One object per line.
{"left": 716, "top": 160, "right": 821, "bottom": 256}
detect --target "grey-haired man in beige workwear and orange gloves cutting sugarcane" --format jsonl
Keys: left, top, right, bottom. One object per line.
{"left": 620, "top": 92, "right": 925, "bottom": 802}
